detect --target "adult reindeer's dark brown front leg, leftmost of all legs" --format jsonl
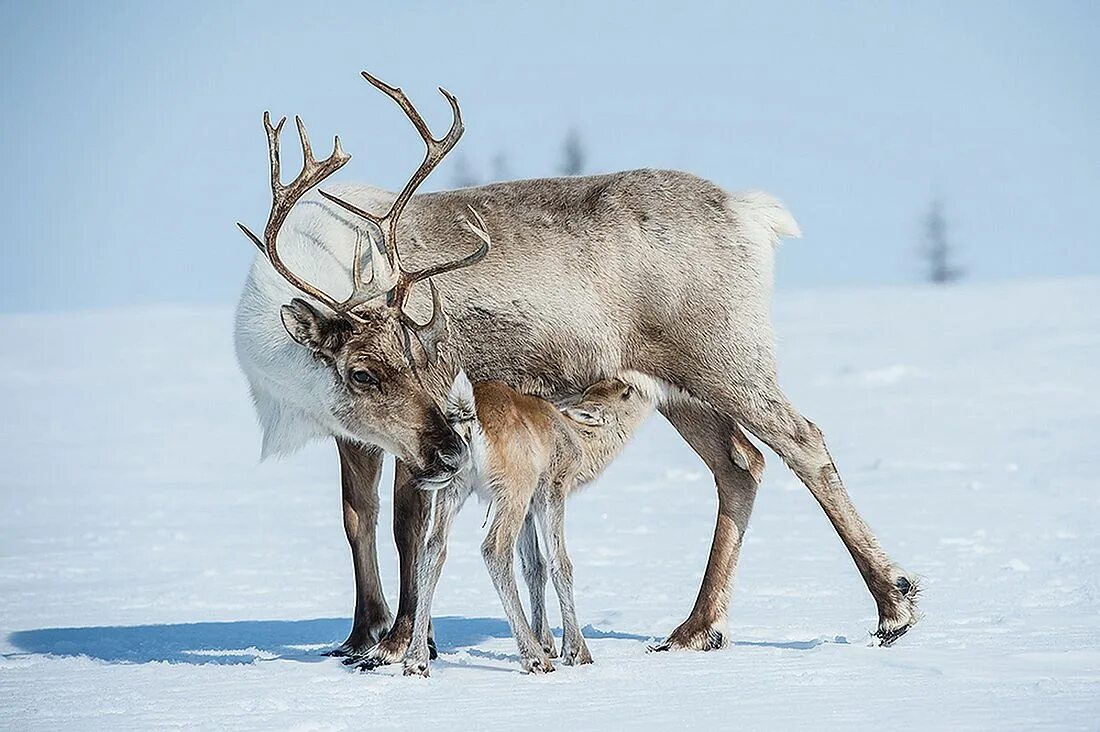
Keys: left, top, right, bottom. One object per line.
{"left": 328, "top": 439, "right": 391, "bottom": 656}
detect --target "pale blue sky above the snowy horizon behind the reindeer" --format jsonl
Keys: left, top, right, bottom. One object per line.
{"left": 0, "top": 0, "right": 1100, "bottom": 310}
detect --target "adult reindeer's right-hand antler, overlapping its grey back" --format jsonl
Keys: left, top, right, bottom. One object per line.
{"left": 320, "top": 72, "right": 491, "bottom": 310}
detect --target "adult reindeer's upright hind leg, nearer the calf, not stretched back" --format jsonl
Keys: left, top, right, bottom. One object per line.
{"left": 655, "top": 401, "right": 763, "bottom": 651}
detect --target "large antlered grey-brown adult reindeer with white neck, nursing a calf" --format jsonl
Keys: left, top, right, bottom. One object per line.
{"left": 237, "top": 72, "right": 916, "bottom": 666}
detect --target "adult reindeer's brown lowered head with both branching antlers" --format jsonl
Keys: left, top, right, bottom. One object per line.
{"left": 238, "top": 72, "right": 492, "bottom": 478}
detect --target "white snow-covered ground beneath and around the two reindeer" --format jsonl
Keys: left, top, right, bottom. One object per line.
{"left": 0, "top": 280, "right": 1100, "bottom": 730}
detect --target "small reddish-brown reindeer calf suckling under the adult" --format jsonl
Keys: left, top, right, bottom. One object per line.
{"left": 405, "top": 372, "right": 656, "bottom": 676}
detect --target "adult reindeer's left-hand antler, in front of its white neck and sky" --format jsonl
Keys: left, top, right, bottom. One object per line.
{"left": 237, "top": 112, "right": 391, "bottom": 317}
